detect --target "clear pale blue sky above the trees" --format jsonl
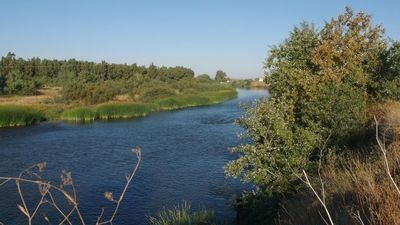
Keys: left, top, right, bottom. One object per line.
{"left": 0, "top": 0, "right": 400, "bottom": 78}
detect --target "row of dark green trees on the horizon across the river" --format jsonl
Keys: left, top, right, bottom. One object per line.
{"left": 0, "top": 53, "right": 229, "bottom": 95}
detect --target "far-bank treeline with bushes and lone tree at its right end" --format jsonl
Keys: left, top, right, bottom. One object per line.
{"left": 0, "top": 53, "right": 234, "bottom": 104}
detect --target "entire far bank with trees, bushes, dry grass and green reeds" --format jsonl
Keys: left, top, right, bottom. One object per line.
{"left": 0, "top": 53, "right": 237, "bottom": 127}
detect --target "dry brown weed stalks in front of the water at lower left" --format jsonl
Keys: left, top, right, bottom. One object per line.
{"left": 0, "top": 147, "right": 142, "bottom": 225}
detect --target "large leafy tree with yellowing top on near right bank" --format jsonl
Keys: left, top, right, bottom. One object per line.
{"left": 226, "top": 9, "right": 400, "bottom": 193}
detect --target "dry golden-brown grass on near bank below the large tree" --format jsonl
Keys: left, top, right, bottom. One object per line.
{"left": 276, "top": 102, "right": 400, "bottom": 225}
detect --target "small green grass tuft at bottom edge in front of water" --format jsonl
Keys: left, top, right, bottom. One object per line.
{"left": 149, "top": 202, "right": 216, "bottom": 225}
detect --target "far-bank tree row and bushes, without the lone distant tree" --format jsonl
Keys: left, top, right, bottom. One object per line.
{"left": 0, "top": 53, "right": 194, "bottom": 100}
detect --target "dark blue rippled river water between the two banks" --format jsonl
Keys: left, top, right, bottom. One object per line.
{"left": 0, "top": 90, "right": 267, "bottom": 225}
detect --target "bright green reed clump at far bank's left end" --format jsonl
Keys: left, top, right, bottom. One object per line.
{"left": 0, "top": 105, "right": 44, "bottom": 127}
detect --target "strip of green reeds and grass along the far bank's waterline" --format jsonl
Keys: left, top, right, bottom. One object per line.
{"left": 0, "top": 89, "right": 237, "bottom": 127}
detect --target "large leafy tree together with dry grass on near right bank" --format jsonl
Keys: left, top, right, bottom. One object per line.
{"left": 226, "top": 8, "right": 400, "bottom": 225}
